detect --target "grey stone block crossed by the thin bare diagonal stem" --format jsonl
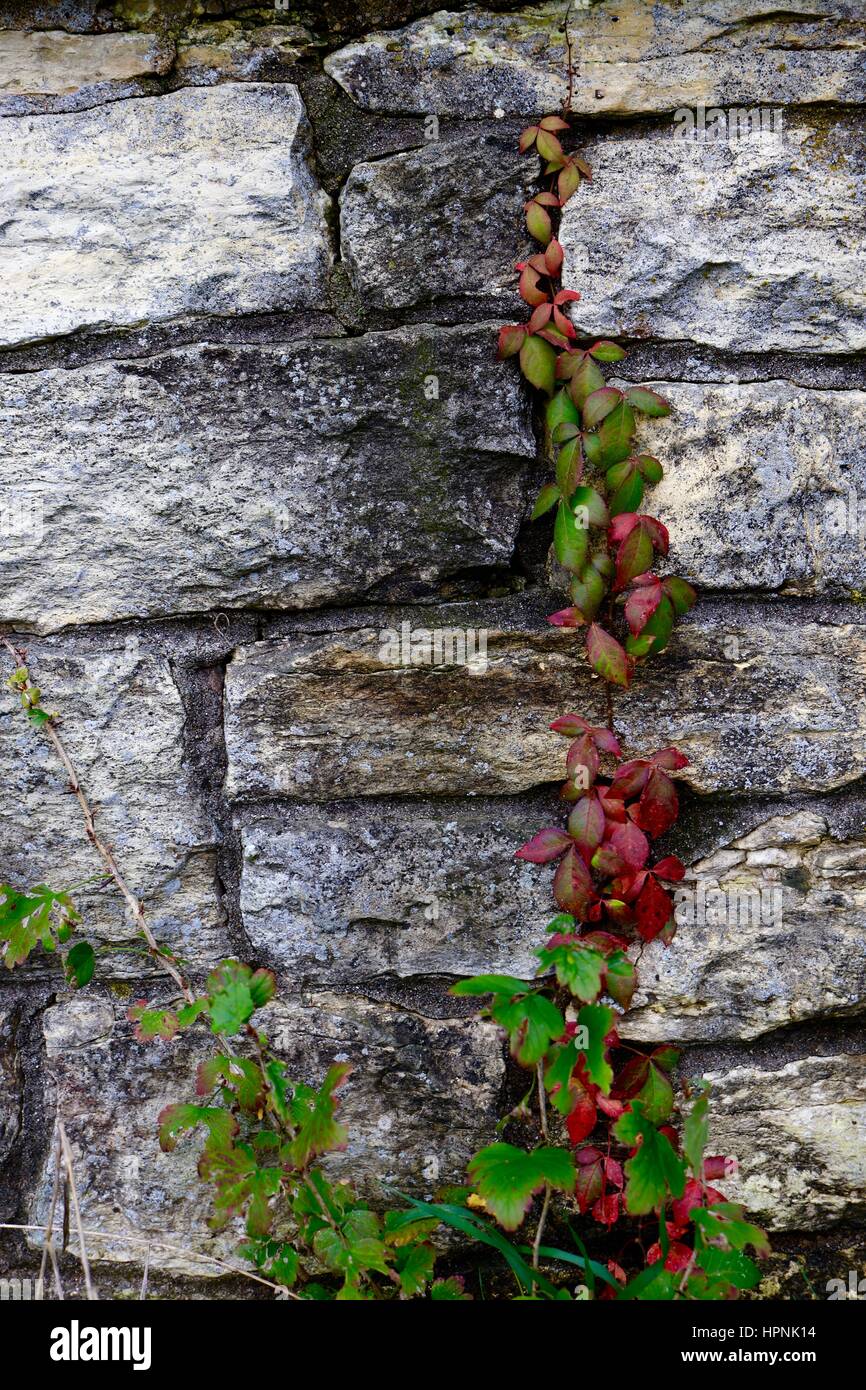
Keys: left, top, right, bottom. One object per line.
{"left": 0, "top": 637, "right": 231, "bottom": 977}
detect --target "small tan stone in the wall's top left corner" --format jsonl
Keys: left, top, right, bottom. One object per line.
{"left": 0, "top": 29, "right": 174, "bottom": 96}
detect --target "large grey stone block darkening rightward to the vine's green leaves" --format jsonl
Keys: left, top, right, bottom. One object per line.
{"left": 0, "top": 325, "right": 535, "bottom": 631}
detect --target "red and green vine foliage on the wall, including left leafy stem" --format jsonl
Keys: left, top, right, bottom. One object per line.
{"left": 0, "top": 115, "right": 767, "bottom": 1301}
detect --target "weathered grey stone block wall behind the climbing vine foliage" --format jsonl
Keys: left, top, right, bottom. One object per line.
{"left": 0, "top": 0, "right": 866, "bottom": 1291}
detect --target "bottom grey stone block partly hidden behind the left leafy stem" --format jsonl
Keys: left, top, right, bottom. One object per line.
{"left": 31, "top": 991, "right": 503, "bottom": 1275}
